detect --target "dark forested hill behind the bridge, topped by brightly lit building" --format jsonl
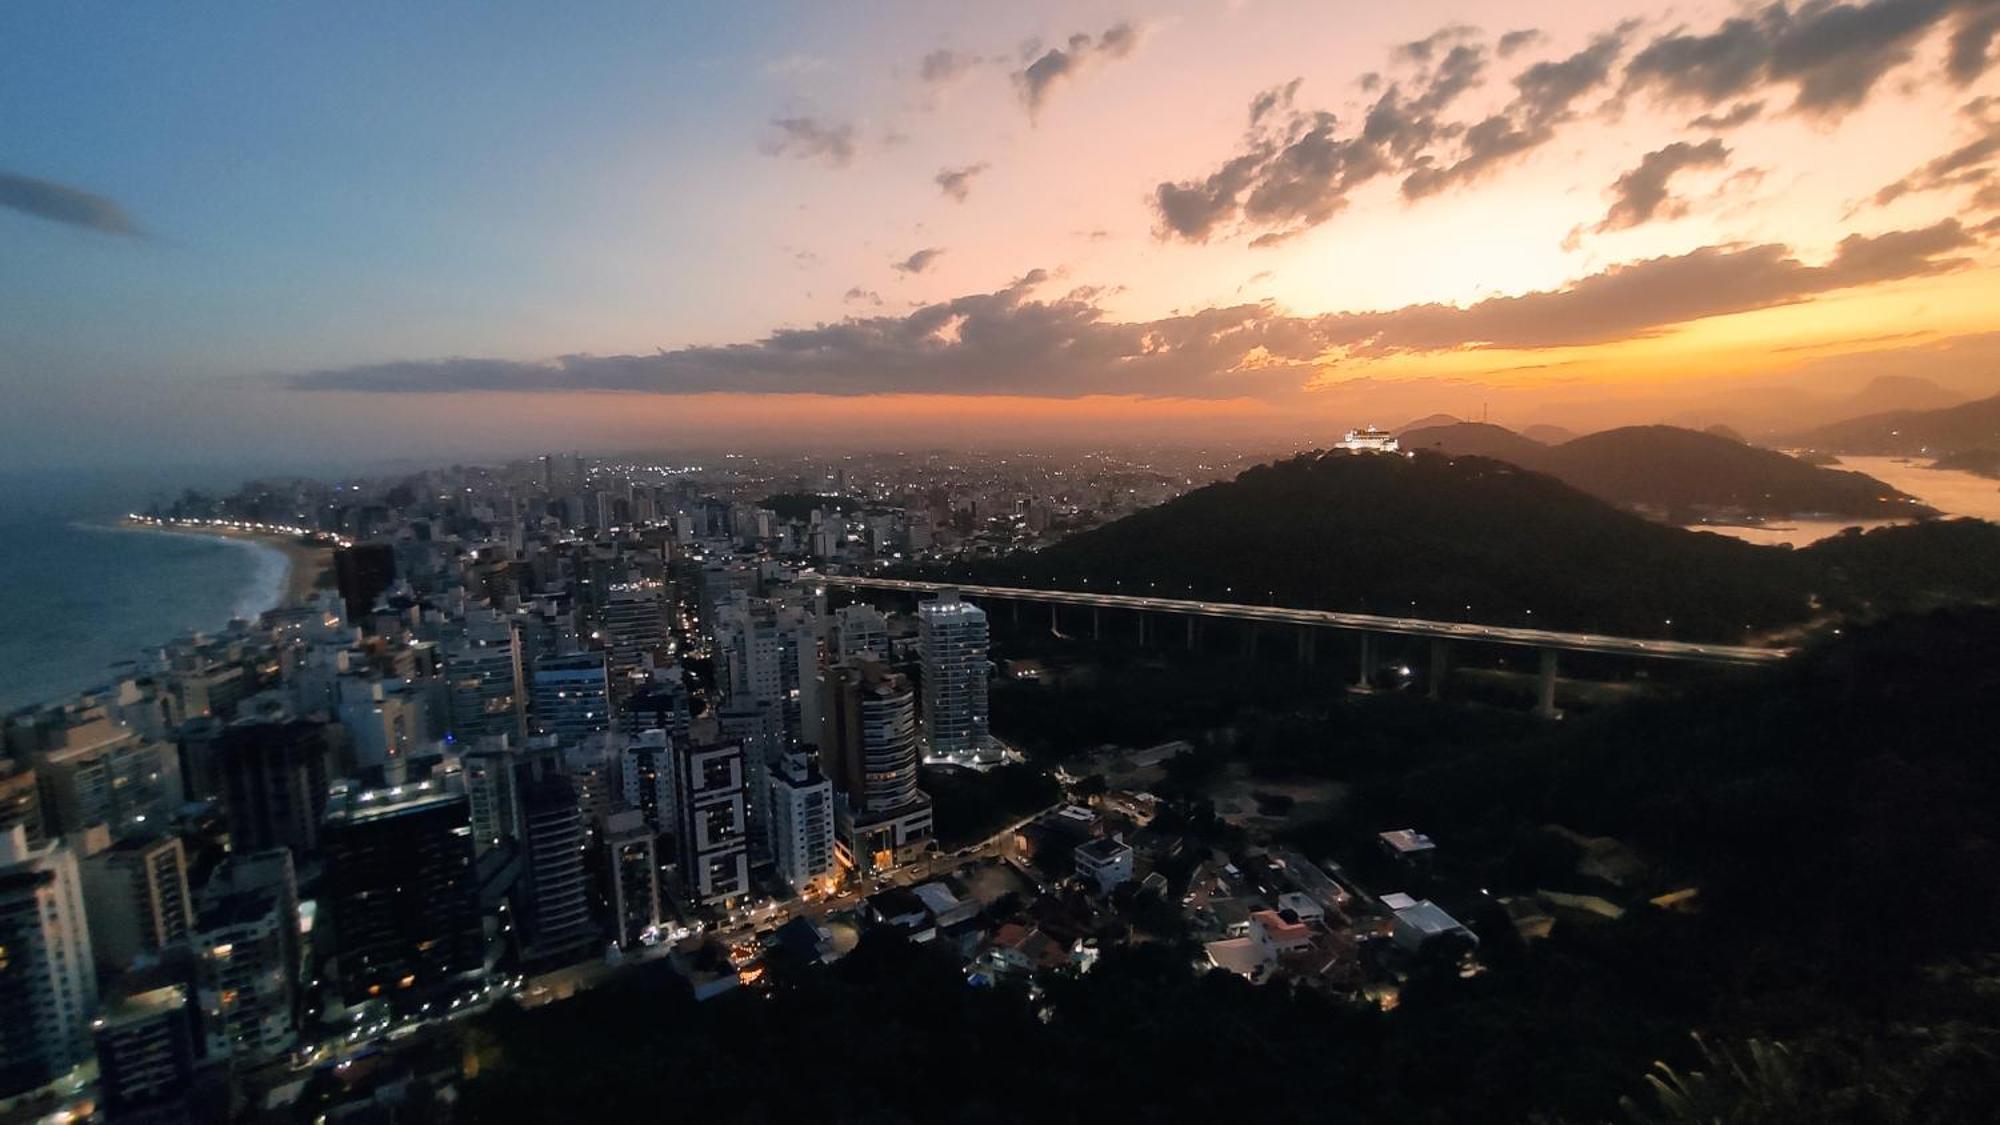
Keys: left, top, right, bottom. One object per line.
{"left": 956, "top": 446, "right": 2000, "bottom": 641}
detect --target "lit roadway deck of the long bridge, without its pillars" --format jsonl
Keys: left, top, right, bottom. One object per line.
{"left": 816, "top": 575, "right": 1792, "bottom": 665}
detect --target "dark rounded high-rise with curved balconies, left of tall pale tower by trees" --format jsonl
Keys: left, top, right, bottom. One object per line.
{"left": 820, "top": 657, "right": 932, "bottom": 875}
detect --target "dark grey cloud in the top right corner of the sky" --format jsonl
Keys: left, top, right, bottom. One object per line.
{"left": 1626, "top": 0, "right": 2000, "bottom": 118}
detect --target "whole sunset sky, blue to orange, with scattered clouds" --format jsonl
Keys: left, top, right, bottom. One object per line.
{"left": 0, "top": 0, "right": 2000, "bottom": 468}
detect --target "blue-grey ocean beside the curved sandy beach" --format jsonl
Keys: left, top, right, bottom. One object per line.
{"left": 0, "top": 474, "right": 288, "bottom": 711}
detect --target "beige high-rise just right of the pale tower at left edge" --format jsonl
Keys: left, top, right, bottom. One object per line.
{"left": 76, "top": 825, "right": 194, "bottom": 973}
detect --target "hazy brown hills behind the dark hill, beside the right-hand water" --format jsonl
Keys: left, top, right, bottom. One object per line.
{"left": 1402, "top": 422, "right": 1936, "bottom": 522}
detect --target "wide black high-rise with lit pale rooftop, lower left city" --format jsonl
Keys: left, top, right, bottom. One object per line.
{"left": 320, "top": 781, "right": 484, "bottom": 1007}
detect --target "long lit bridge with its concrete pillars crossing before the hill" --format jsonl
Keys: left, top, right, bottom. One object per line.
{"left": 814, "top": 575, "right": 1792, "bottom": 715}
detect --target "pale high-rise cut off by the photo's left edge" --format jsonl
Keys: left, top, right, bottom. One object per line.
{"left": 0, "top": 825, "right": 98, "bottom": 1097}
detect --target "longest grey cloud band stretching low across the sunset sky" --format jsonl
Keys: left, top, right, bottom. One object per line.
{"left": 284, "top": 220, "right": 1974, "bottom": 398}
